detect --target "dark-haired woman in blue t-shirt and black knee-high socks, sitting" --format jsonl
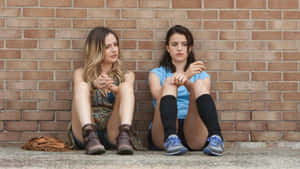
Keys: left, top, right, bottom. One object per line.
{"left": 148, "top": 25, "right": 224, "bottom": 156}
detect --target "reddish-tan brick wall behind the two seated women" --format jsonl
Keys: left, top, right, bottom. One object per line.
{"left": 0, "top": 0, "right": 300, "bottom": 143}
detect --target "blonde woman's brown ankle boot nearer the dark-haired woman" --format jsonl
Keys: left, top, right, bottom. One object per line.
{"left": 117, "top": 124, "right": 133, "bottom": 154}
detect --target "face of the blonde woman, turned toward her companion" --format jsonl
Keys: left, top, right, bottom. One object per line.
{"left": 103, "top": 33, "right": 119, "bottom": 64}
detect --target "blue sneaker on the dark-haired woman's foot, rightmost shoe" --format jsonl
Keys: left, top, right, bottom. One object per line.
{"left": 203, "top": 135, "right": 224, "bottom": 156}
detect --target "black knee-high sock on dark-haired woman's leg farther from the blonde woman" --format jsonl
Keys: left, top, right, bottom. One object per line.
{"left": 196, "top": 94, "right": 222, "bottom": 137}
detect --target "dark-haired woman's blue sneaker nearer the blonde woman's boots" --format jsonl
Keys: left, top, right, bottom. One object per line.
{"left": 164, "top": 134, "right": 187, "bottom": 155}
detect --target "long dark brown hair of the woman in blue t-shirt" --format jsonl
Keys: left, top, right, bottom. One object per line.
{"left": 160, "top": 25, "right": 195, "bottom": 73}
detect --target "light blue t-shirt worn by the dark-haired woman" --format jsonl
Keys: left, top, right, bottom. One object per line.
{"left": 150, "top": 66, "right": 210, "bottom": 119}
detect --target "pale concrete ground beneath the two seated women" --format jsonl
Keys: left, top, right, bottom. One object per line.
{"left": 0, "top": 147, "right": 300, "bottom": 169}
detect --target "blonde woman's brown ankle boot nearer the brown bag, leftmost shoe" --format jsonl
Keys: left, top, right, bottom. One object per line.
{"left": 82, "top": 124, "right": 105, "bottom": 155}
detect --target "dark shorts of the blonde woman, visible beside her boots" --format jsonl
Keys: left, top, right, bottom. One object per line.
{"left": 69, "top": 128, "right": 117, "bottom": 150}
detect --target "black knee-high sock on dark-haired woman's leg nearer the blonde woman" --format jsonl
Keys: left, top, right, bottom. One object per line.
{"left": 159, "top": 95, "right": 177, "bottom": 140}
